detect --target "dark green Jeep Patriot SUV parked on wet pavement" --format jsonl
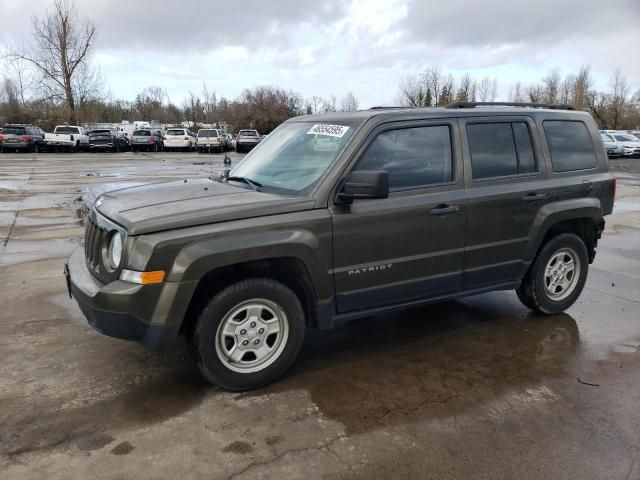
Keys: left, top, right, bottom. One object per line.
{"left": 66, "top": 103, "right": 615, "bottom": 390}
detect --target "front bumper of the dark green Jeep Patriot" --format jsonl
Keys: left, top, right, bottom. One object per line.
{"left": 65, "top": 248, "right": 179, "bottom": 349}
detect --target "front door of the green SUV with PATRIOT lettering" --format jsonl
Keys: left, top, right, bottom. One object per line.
{"left": 330, "top": 120, "right": 467, "bottom": 313}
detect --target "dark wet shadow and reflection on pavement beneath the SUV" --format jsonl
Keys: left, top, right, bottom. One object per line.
{"left": 239, "top": 292, "right": 580, "bottom": 434}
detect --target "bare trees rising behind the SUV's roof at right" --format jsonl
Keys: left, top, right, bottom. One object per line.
{"left": 397, "top": 65, "right": 640, "bottom": 130}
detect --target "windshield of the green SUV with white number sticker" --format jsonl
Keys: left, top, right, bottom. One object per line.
{"left": 229, "top": 122, "right": 356, "bottom": 195}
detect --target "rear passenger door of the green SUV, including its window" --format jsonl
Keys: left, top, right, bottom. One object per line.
{"left": 460, "top": 116, "right": 553, "bottom": 290}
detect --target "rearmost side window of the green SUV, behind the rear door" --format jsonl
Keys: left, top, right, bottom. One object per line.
{"left": 542, "top": 120, "right": 598, "bottom": 172}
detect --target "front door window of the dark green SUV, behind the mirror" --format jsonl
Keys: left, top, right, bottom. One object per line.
{"left": 356, "top": 125, "right": 453, "bottom": 191}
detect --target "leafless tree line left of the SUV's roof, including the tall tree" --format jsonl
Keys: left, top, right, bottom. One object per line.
{"left": 0, "top": 0, "right": 359, "bottom": 133}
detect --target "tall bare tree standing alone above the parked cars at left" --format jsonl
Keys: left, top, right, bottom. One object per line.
{"left": 10, "top": 0, "right": 98, "bottom": 122}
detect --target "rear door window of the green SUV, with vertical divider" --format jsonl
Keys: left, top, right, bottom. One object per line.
{"left": 467, "top": 122, "right": 537, "bottom": 180}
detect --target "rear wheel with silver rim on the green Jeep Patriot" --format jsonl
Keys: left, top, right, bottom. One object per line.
{"left": 516, "top": 233, "right": 589, "bottom": 315}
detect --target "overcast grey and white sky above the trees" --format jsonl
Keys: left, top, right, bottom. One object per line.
{"left": 0, "top": 0, "right": 640, "bottom": 107}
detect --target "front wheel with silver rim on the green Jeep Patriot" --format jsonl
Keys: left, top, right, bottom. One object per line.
{"left": 189, "top": 278, "right": 306, "bottom": 391}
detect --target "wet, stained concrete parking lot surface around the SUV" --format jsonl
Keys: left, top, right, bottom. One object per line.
{"left": 0, "top": 153, "right": 640, "bottom": 480}
